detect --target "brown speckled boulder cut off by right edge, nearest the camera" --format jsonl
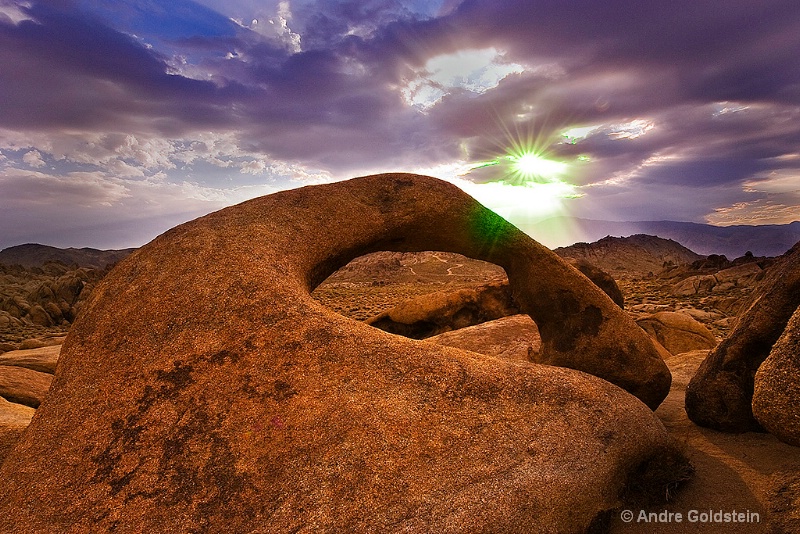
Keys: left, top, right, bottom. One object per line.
{"left": 753, "top": 307, "right": 800, "bottom": 446}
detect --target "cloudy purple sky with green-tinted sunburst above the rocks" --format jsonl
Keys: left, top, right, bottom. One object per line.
{"left": 0, "top": 0, "right": 800, "bottom": 248}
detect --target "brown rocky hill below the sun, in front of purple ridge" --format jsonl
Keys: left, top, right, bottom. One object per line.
{"left": 553, "top": 234, "right": 703, "bottom": 277}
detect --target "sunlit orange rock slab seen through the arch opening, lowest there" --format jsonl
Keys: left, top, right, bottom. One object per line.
{"left": 426, "top": 314, "right": 542, "bottom": 361}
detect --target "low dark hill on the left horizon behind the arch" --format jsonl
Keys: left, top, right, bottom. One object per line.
{"left": 0, "top": 243, "right": 136, "bottom": 269}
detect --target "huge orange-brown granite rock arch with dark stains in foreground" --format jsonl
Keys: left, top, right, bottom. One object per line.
{"left": 0, "top": 174, "right": 681, "bottom": 533}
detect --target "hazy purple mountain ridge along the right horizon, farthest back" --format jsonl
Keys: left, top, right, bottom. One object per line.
{"left": 525, "top": 217, "right": 800, "bottom": 259}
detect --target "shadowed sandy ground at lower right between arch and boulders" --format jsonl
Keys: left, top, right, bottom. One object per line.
{"left": 611, "top": 351, "right": 800, "bottom": 534}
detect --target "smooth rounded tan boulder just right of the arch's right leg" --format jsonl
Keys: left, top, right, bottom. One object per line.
{"left": 636, "top": 311, "right": 717, "bottom": 354}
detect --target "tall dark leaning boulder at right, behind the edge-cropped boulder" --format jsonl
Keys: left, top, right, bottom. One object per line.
{"left": 686, "top": 243, "right": 800, "bottom": 432}
